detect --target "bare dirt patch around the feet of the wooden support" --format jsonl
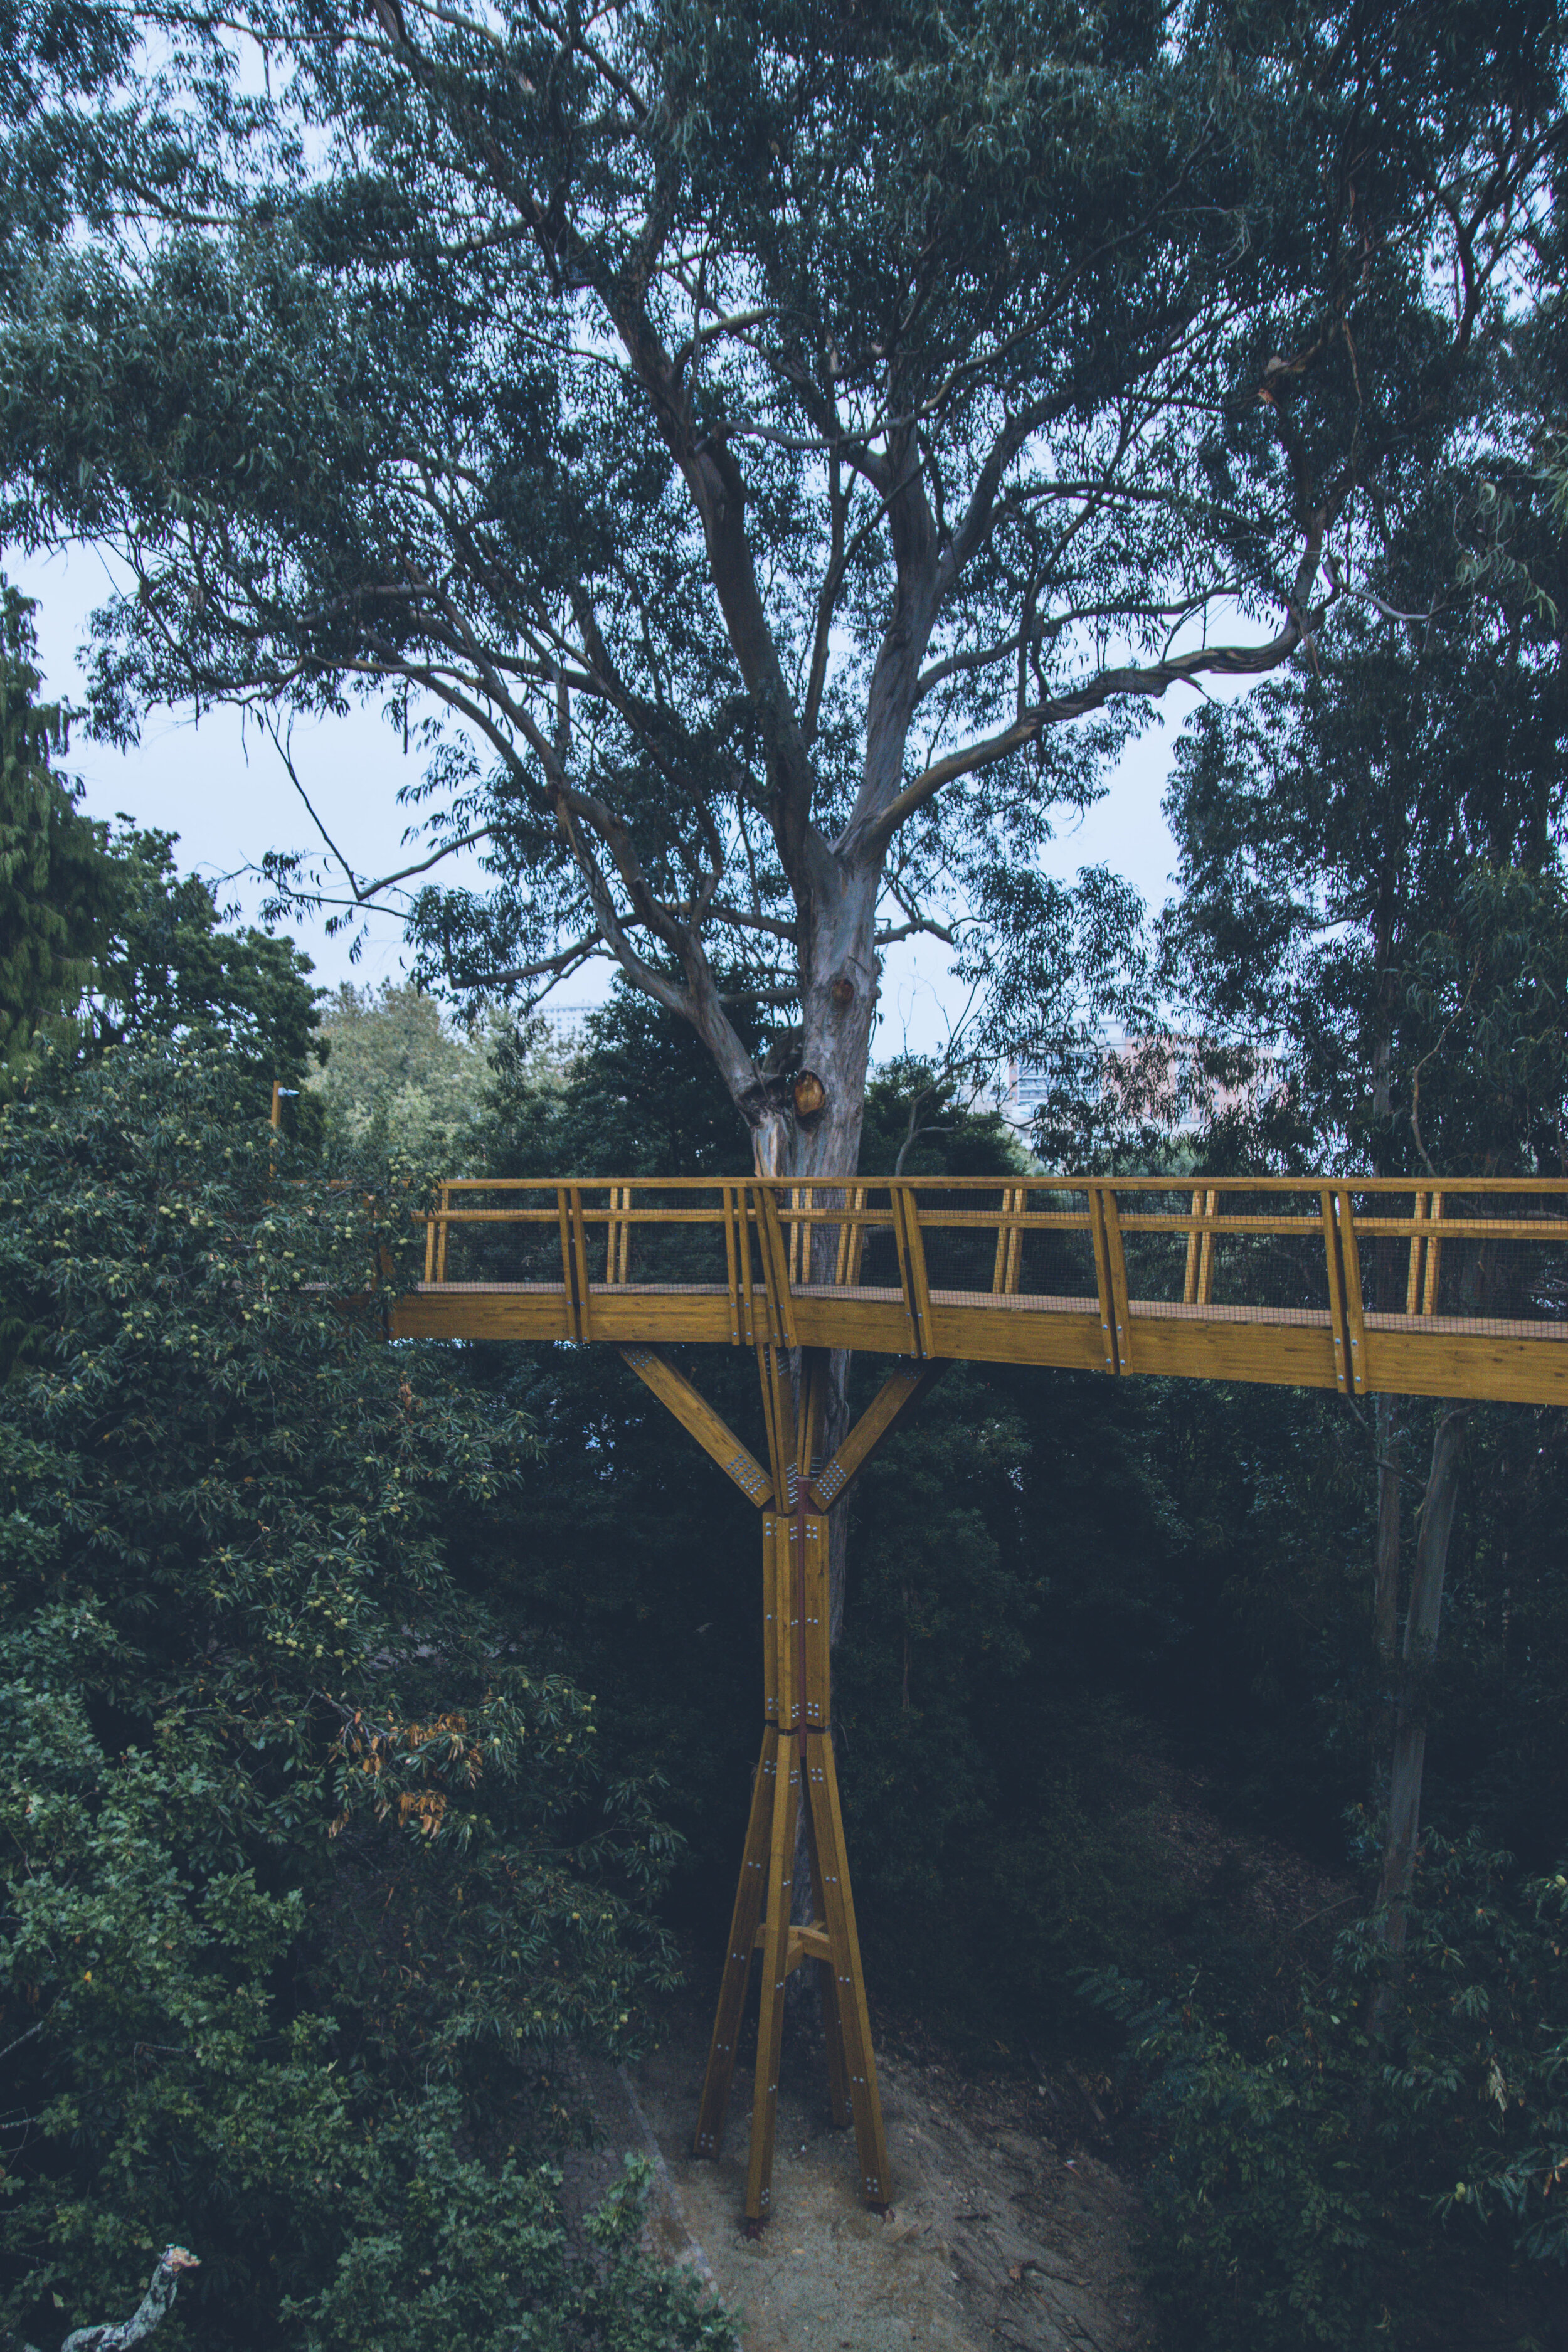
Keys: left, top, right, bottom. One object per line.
{"left": 569, "top": 2004, "right": 1152, "bottom": 2352}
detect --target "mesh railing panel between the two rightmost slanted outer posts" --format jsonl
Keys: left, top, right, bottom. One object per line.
{"left": 1116, "top": 1183, "right": 1330, "bottom": 1322}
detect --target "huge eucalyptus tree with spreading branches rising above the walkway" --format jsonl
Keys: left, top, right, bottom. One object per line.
{"left": 0, "top": 0, "right": 1561, "bottom": 1173}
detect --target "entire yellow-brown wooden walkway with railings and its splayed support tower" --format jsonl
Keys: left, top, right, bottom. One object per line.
{"left": 390, "top": 1176, "right": 1568, "bottom": 2227}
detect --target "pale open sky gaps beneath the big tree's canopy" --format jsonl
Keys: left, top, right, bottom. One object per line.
{"left": 4, "top": 548, "right": 1194, "bottom": 1059}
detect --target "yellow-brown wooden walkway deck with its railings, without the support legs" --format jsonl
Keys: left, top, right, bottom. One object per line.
{"left": 393, "top": 1176, "right": 1568, "bottom": 1404}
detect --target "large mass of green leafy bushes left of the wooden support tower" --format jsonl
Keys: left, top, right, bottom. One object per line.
{"left": 0, "top": 1049, "right": 707, "bottom": 2352}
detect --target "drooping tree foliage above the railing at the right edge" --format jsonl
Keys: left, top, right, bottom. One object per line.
{"left": 1166, "top": 588, "right": 1568, "bottom": 1173}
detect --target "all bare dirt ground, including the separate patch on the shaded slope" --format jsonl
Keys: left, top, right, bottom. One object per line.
{"left": 566, "top": 1766, "right": 1354, "bottom": 2352}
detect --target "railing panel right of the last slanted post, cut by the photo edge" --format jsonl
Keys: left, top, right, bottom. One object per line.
{"left": 1349, "top": 1185, "right": 1568, "bottom": 1338}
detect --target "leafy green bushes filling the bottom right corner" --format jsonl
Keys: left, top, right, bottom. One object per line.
{"left": 1086, "top": 1835, "right": 1568, "bottom": 2352}
